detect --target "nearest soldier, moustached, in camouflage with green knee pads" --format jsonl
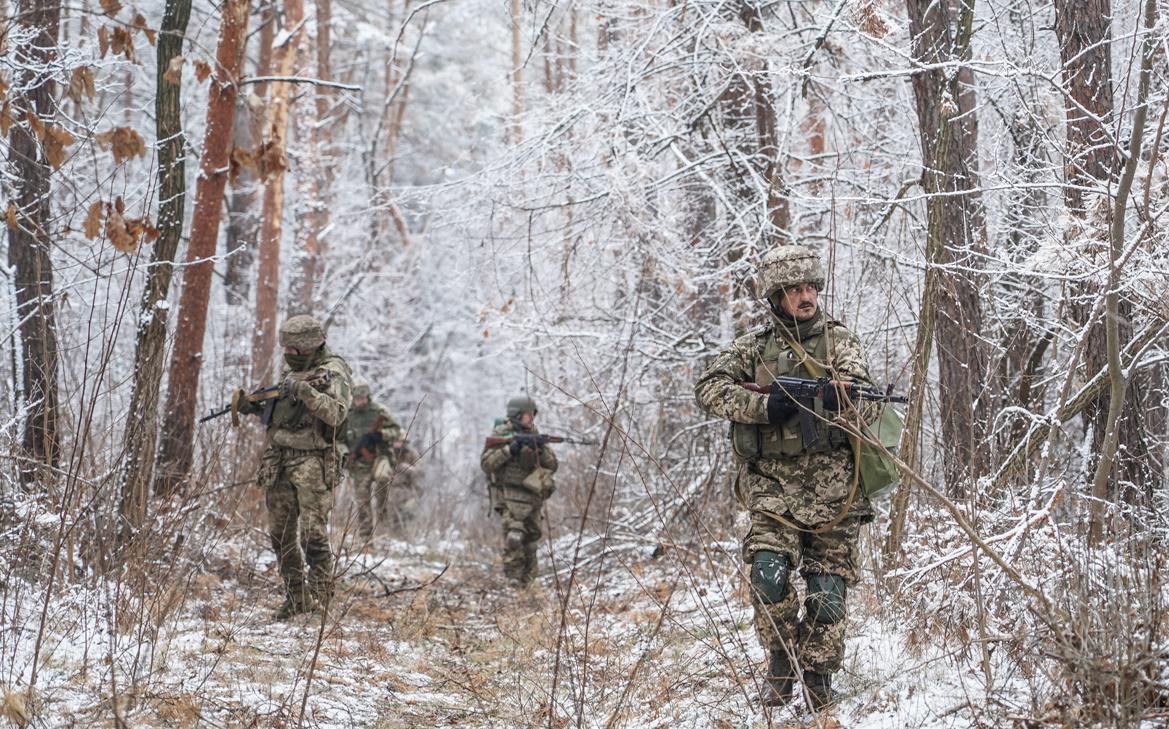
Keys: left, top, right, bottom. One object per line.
{"left": 694, "top": 245, "right": 872, "bottom": 710}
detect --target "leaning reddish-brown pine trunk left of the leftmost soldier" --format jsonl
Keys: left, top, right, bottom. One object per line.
{"left": 154, "top": 0, "right": 248, "bottom": 495}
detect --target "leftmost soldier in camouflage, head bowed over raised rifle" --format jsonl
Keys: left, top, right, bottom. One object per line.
{"left": 234, "top": 315, "right": 350, "bottom": 620}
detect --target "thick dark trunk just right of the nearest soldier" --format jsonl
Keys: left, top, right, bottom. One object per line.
{"left": 906, "top": 0, "right": 994, "bottom": 498}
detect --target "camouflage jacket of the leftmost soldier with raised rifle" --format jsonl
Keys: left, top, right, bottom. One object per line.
{"left": 240, "top": 347, "right": 352, "bottom": 451}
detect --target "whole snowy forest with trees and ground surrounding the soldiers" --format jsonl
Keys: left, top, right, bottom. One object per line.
{"left": 0, "top": 0, "right": 1169, "bottom": 729}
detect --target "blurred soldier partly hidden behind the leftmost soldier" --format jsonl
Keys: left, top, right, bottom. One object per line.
{"left": 346, "top": 379, "right": 419, "bottom": 541}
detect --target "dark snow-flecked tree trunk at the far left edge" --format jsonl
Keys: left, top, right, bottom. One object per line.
{"left": 8, "top": 0, "right": 61, "bottom": 485}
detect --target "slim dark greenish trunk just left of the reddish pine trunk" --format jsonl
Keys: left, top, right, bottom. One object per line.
{"left": 120, "top": 0, "right": 191, "bottom": 535}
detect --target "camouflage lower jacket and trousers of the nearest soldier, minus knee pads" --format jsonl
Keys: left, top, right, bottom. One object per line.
{"left": 741, "top": 464, "right": 870, "bottom": 673}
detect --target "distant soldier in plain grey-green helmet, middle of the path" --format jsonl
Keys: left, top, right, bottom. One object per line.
{"left": 479, "top": 395, "right": 559, "bottom": 588}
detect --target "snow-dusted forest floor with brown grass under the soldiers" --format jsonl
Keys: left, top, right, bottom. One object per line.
{"left": 0, "top": 490, "right": 1075, "bottom": 729}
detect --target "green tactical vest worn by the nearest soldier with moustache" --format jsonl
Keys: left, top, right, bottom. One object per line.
{"left": 731, "top": 324, "right": 848, "bottom": 460}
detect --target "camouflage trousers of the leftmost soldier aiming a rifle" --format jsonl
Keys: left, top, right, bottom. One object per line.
{"left": 256, "top": 446, "right": 341, "bottom": 603}
